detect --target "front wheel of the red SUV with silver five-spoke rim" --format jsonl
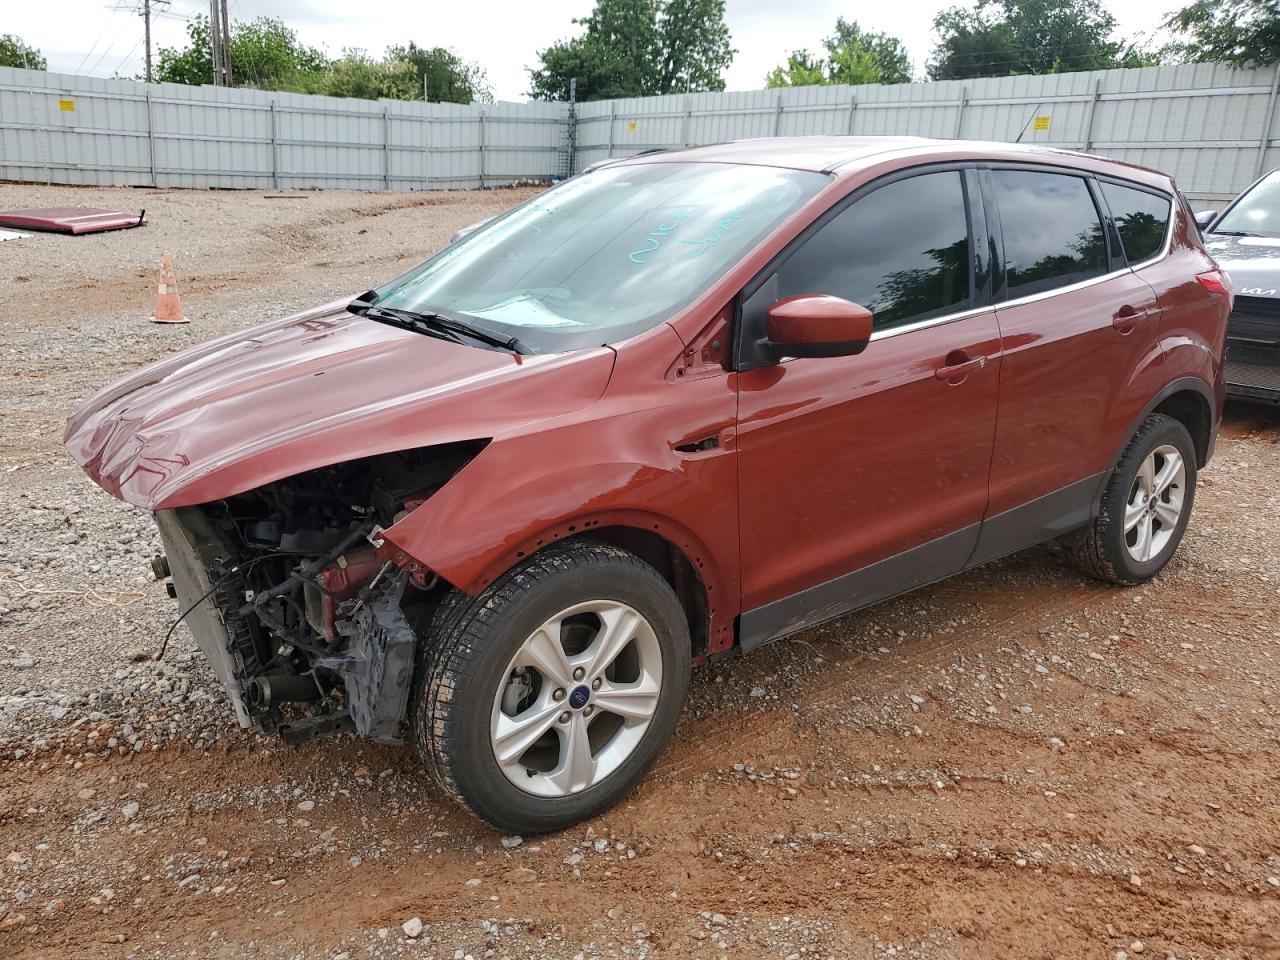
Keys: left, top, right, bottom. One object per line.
{"left": 411, "top": 540, "right": 691, "bottom": 833}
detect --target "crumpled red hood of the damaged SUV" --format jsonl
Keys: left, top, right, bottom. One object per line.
{"left": 65, "top": 301, "right": 614, "bottom": 509}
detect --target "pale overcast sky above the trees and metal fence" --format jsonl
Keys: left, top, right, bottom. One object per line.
{"left": 15, "top": 0, "right": 1183, "bottom": 101}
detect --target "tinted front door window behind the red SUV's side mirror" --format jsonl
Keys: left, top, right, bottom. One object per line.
{"left": 778, "top": 170, "right": 970, "bottom": 329}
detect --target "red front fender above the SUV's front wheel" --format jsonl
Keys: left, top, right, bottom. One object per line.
{"left": 383, "top": 335, "right": 740, "bottom": 649}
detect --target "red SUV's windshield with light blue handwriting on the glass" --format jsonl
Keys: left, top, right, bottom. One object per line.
{"left": 375, "top": 163, "right": 829, "bottom": 352}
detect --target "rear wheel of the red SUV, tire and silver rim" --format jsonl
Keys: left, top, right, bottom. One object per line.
{"left": 1066, "top": 413, "right": 1196, "bottom": 585}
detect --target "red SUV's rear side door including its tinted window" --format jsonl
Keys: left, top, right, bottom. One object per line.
{"left": 974, "top": 166, "right": 1162, "bottom": 562}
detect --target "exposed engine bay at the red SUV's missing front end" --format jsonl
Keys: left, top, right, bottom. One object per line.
{"left": 155, "top": 440, "right": 486, "bottom": 744}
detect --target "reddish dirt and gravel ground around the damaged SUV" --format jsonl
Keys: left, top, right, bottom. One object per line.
{"left": 0, "top": 184, "right": 1280, "bottom": 960}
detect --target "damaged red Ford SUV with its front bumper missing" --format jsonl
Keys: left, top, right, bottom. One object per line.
{"left": 67, "top": 137, "right": 1231, "bottom": 832}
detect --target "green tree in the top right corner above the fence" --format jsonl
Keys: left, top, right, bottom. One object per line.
{"left": 1162, "top": 0, "right": 1280, "bottom": 67}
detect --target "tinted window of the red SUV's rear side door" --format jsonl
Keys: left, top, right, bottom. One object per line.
{"left": 991, "top": 170, "right": 1107, "bottom": 298}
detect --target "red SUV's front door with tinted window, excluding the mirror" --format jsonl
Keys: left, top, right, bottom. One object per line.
{"left": 737, "top": 169, "right": 1000, "bottom": 648}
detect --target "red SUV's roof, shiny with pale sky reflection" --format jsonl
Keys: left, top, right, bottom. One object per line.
{"left": 608, "top": 137, "right": 1172, "bottom": 189}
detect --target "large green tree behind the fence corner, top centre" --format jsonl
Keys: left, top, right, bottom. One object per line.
{"left": 529, "top": 0, "right": 735, "bottom": 100}
